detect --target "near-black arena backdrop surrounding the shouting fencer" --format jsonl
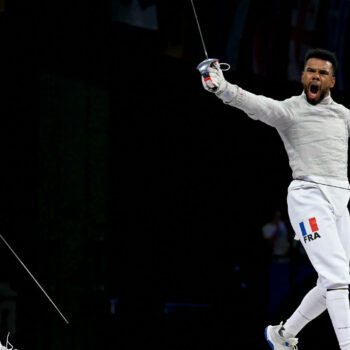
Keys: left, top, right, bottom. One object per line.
{"left": 0, "top": 0, "right": 350, "bottom": 350}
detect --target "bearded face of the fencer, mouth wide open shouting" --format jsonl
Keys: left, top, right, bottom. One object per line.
{"left": 301, "top": 58, "right": 335, "bottom": 105}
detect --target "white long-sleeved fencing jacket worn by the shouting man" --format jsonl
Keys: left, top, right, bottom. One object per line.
{"left": 218, "top": 83, "right": 350, "bottom": 215}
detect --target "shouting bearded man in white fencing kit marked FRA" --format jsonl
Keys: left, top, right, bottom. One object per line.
{"left": 202, "top": 49, "right": 350, "bottom": 350}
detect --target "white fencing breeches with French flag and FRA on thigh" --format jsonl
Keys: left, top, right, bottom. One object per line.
{"left": 287, "top": 187, "right": 350, "bottom": 289}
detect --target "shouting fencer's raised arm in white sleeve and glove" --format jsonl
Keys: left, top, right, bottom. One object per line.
{"left": 202, "top": 63, "right": 292, "bottom": 128}
